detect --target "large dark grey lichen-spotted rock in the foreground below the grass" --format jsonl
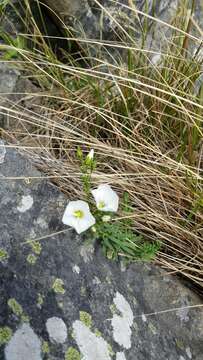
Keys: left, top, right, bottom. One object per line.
{"left": 0, "top": 144, "right": 203, "bottom": 360}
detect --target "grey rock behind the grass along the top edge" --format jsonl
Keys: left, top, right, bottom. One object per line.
{"left": 43, "top": 0, "right": 203, "bottom": 48}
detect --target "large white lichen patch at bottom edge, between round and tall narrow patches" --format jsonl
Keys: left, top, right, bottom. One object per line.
{"left": 73, "top": 320, "right": 111, "bottom": 360}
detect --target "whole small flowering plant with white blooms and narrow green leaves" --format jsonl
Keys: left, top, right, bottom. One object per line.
{"left": 62, "top": 148, "right": 160, "bottom": 261}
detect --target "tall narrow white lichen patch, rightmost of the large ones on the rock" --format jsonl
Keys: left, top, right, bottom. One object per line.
{"left": 111, "top": 292, "right": 134, "bottom": 349}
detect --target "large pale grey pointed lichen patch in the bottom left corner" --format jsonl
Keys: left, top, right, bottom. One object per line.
{"left": 5, "top": 324, "right": 42, "bottom": 360}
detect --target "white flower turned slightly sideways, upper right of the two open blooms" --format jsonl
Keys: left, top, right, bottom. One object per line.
{"left": 92, "top": 184, "right": 119, "bottom": 212}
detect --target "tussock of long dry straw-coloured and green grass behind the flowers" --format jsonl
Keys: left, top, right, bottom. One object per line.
{"left": 0, "top": 0, "right": 203, "bottom": 287}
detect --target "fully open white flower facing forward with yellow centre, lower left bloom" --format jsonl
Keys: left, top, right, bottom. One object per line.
{"left": 62, "top": 200, "right": 95, "bottom": 234}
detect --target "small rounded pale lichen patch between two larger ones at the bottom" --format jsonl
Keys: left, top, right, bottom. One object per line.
{"left": 46, "top": 317, "right": 68, "bottom": 344}
